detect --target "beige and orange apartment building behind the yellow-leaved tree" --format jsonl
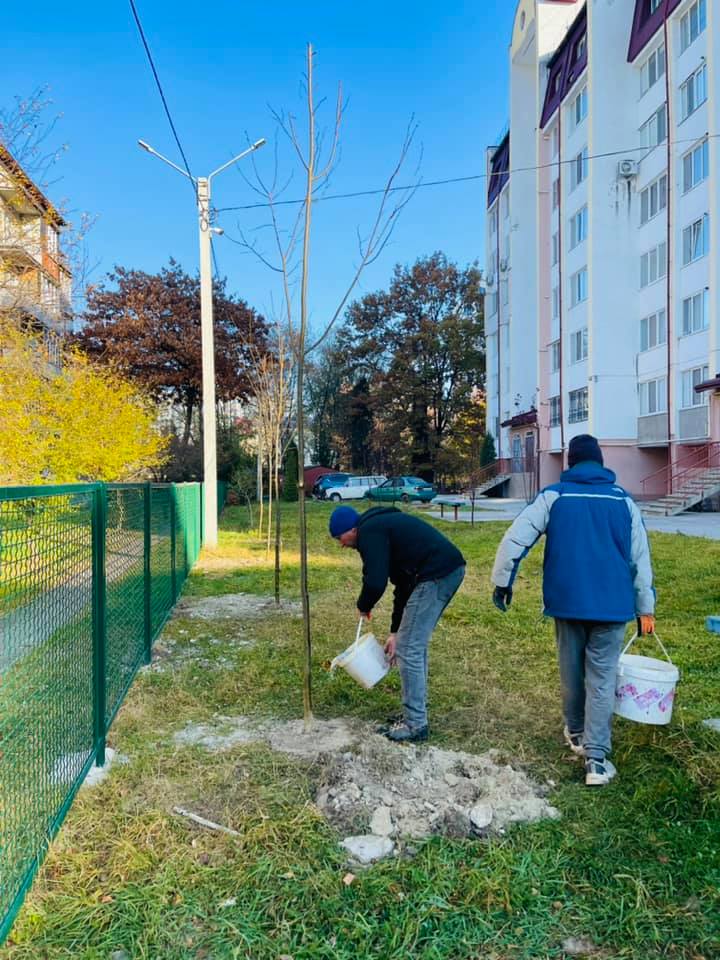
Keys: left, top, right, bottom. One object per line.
{"left": 0, "top": 145, "right": 71, "bottom": 341}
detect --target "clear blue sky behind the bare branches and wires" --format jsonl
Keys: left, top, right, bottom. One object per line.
{"left": 0, "top": 0, "right": 515, "bottom": 322}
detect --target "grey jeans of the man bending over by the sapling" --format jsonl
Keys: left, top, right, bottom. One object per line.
{"left": 395, "top": 566, "right": 465, "bottom": 730}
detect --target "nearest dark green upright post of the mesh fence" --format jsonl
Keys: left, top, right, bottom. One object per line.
{"left": 92, "top": 483, "right": 107, "bottom": 767}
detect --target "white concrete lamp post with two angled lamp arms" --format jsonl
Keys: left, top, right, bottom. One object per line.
{"left": 138, "top": 139, "right": 265, "bottom": 547}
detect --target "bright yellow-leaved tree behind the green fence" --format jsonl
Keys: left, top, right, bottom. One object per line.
{"left": 0, "top": 320, "right": 167, "bottom": 484}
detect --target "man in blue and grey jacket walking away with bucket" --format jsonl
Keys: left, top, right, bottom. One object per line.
{"left": 492, "top": 434, "right": 655, "bottom": 786}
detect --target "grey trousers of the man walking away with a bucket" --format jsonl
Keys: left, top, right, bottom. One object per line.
{"left": 555, "top": 620, "right": 625, "bottom": 760}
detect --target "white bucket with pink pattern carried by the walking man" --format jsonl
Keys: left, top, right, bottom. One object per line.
{"left": 615, "top": 634, "right": 680, "bottom": 725}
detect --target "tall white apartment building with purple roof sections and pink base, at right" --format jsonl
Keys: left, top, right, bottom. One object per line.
{"left": 486, "top": 0, "right": 720, "bottom": 496}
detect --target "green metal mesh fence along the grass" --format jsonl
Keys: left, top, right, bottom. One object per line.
{"left": 0, "top": 483, "right": 226, "bottom": 943}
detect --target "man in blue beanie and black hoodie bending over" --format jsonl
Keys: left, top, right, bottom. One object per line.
{"left": 330, "top": 506, "right": 465, "bottom": 743}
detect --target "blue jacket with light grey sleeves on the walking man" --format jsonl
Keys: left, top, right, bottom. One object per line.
{"left": 492, "top": 462, "right": 655, "bottom": 623}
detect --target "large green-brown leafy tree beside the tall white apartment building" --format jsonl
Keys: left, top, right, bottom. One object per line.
{"left": 337, "top": 253, "right": 485, "bottom": 479}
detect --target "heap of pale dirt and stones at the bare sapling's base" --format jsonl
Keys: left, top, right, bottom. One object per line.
{"left": 174, "top": 717, "right": 560, "bottom": 839}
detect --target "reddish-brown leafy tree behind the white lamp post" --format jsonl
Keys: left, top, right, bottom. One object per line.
{"left": 75, "top": 260, "right": 267, "bottom": 456}
